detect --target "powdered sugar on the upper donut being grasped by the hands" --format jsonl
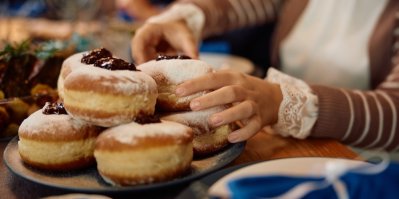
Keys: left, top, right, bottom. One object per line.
{"left": 137, "top": 59, "right": 213, "bottom": 84}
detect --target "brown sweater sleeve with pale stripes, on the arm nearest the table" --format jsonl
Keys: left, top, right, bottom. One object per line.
{"left": 311, "top": 62, "right": 399, "bottom": 151}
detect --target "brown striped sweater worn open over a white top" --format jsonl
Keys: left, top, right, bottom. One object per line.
{"left": 180, "top": 0, "right": 399, "bottom": 150}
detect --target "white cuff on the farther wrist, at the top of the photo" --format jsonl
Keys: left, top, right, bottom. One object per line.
{"left": 146, "top": 3, "right": 205, "bottom": 43}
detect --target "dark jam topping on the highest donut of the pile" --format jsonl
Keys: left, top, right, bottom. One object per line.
{"left": 81, "top": 48, "right": 137, "bottom": 71}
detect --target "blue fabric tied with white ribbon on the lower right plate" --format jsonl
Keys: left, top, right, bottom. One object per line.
{"left": 228, "top": 163, "right": 399, "bottom": 199}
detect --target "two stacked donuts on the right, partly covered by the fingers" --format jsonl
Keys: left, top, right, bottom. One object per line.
{"left": 138, "top": 56, "right": 235, "bottom": 156}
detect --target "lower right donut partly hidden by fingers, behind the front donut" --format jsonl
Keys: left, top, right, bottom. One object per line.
{"left": 162, "top": 106, "right": 237, "bottom": 156}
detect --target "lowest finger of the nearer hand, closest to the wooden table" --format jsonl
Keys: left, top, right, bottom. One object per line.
{"left": 227, "top": 115, "right": 262, "bottom": 143}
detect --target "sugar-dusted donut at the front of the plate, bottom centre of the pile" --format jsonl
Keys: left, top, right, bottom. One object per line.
{"left": 94, "top": 119, "right": 193, "bottom": 185}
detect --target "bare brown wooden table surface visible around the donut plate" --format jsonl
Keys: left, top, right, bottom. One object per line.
{"left": 0, "top": 131, "right": 357, "bottom": 199}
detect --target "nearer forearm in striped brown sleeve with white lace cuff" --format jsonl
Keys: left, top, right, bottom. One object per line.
{"left": 267, "top": 67, "right": 399, "bottom": 151}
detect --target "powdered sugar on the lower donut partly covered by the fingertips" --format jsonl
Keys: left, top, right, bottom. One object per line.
{"left": 161, "top": 106, "right": 225, "bottom": 131}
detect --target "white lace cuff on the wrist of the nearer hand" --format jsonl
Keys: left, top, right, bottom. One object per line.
{"left": 266, "top": 68, "right": 318, "bottom": 139}
